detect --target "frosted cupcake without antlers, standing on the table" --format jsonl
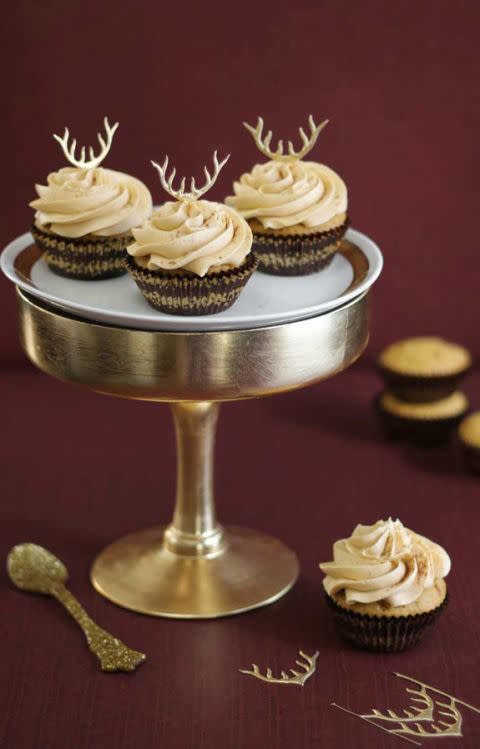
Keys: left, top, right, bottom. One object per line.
{"left": 320, "top": 518, "right": 450, "bottom": 652}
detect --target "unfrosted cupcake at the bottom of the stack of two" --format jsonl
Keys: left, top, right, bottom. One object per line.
{"left": 375, "top": 390, "right": 469, "bottom": 444}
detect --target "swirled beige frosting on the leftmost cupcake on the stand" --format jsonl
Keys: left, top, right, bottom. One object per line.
{"left": 30, "top": 167, "right": 152, "bottom": 238}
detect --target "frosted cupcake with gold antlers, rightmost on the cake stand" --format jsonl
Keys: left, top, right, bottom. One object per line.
{"left": 225, "top": 115, "right": 348, "bottom": 276}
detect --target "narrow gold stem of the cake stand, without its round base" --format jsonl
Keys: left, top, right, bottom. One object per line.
{"left": 164, "top": 401, "right": 224, "bottom": 557}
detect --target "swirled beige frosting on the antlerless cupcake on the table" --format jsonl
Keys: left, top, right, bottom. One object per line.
{"left": 320, "top": 518, "right": 450, "bottom": 606}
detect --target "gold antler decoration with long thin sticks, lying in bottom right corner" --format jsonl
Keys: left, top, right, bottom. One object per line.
{"left": 332, "top": 672, "right": 480, "bottom": 746}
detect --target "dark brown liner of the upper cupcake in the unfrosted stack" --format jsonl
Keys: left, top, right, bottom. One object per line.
{"left": 378, "top": 364, "right": 471, "bottom": 403}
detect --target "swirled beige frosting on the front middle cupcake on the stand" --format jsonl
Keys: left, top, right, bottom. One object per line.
{"left": 127, "top": 200, "right": 252, "bottom": 276}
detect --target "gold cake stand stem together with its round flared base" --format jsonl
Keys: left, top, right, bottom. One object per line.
{"left": 91, "top": 401, "right": 298, "bottom": 619}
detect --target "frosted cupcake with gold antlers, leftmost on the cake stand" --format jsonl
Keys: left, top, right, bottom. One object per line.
{"left": 30, "top": 117, "right": 152, "bottom": 281}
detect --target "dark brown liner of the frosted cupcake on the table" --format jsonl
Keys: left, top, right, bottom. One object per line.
{"left": 325, "top": 594, "right": 448, "bottom": 653}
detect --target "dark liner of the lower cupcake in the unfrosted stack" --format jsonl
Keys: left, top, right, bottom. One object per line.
{"left": 373, "top": 393, "right": 469, "bottom": 445}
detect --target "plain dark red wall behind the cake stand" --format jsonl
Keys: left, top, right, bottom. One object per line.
{"left": 0, "top": 0, "right": 480, "bottom": 359}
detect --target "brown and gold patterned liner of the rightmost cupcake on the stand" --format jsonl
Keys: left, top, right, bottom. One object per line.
{"left": 252, "top": 218, "right": 350, "bottom": 276}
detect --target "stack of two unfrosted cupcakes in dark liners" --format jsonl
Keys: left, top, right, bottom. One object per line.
{"left": 376, "top": 337, "right": 472, "bottom": 444}
